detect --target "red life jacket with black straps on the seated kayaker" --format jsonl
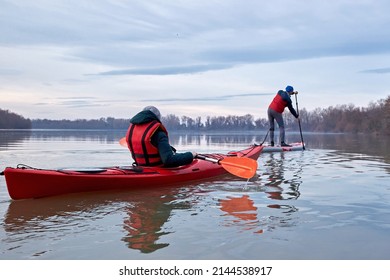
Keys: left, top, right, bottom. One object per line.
{"left": 126, "top": 121, "right": 168, "bottom": 166}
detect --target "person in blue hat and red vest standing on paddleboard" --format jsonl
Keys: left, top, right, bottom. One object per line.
{"left": 268, "top": 86, "right": 299, "bottom": 147}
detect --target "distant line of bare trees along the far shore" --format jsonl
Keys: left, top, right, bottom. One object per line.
{"left": 0, "top": 96, "right": 390, "bottom": 134}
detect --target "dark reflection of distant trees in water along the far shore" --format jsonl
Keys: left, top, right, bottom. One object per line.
{"left": 0, "top": 130, "right": 390, "bottom": 163}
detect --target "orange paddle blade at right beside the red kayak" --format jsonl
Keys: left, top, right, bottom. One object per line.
{"left": 219, "top": 157, "right": 257, "bottom": 179}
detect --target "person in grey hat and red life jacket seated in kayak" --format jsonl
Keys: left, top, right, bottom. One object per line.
{"left": 126, "top": 106, "right": 196, "bottom": 167}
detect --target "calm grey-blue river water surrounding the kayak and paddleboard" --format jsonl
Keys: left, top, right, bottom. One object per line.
{"left": 0, "top": 130, "right": 390, "bottom": 260}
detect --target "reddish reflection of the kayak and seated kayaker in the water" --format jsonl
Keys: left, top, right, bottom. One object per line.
{"left": 2, "top": 183, "right": 213, "bottom": 256}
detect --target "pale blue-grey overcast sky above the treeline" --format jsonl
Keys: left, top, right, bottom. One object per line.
{"left": 0, "top": 0, "right": 390, "bottom": 119}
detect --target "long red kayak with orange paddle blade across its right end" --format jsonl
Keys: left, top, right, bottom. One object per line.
{"left": 3, "top": 145, "right": 263, "bottom": 200}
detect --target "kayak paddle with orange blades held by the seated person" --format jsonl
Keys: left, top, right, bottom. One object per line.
{"left": 119, "top": 137, "right": 257, "bottom": 179}
